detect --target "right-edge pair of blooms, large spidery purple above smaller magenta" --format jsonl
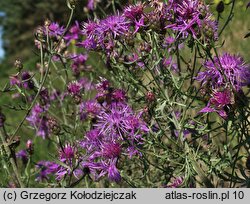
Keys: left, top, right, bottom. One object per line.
{"left": 196, "top": 53, "right": 250, "bottom": 119}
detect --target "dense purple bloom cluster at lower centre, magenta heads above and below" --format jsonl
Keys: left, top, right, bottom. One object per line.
{"left": 80, "top": 79, "right": 149, "bottom": 182}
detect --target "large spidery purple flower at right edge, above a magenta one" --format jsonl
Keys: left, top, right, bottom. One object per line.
{"left": 196, "top": 53, "right": 250, "bottom": 91}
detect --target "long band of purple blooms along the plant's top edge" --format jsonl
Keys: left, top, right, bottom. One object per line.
{"left": 79, "top": 0, "right": 218, "bottom": 51}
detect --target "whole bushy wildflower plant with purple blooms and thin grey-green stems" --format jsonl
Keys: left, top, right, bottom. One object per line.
{"left": 0, "top": 0, "right": 250, "bottom": 188}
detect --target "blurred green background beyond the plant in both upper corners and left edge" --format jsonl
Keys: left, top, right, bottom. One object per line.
{"left": 0, "top": 0, "right": 250, "bottom": 186}
